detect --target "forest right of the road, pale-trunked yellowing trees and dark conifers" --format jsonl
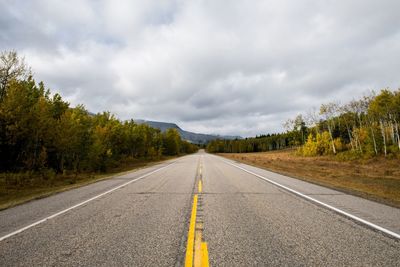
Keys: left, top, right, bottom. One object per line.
{"left": 207, "top": 88, "right": 400, "bottom": 158}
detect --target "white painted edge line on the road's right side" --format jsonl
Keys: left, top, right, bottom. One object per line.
{"left": 222, "top": 160, "right": 400, "bottom": 239}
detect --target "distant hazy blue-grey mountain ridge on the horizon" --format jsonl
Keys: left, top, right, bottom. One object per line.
{"left": 135, "top": 120, "right": 242, "bottom": 144}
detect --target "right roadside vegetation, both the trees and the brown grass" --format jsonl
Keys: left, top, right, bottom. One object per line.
{"left": 207, "top": 86, "right": 400, "bottom": 207}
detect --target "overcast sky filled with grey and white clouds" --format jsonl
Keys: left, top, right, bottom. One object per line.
{"left": 0, "top": 0, "right": 400, "bottom": 137}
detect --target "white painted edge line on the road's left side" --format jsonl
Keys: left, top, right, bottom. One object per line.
{"left": 0, "top": 161, "right": 175, "bottom": 242}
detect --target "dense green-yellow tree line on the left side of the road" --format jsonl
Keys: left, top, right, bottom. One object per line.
{"left": 0, "top": 51, "right": 198, "bottom": 176}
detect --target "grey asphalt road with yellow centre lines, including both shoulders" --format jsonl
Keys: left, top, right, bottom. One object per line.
{"left": 0, "top": 152, "right": 400, "bottom": 266}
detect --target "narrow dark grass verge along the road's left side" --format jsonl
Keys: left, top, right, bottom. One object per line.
{"left": 0, "top": 157, "right": 177, "bottom": 210}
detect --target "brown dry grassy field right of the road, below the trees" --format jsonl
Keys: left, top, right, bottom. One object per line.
{"left": 219, "top": 150, "right": 400, "bottom": 208}
